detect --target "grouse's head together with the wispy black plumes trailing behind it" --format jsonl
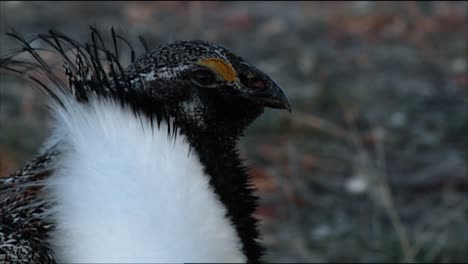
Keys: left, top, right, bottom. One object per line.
{"left": 0, "top": 32, "right": 291, "bottom": 142}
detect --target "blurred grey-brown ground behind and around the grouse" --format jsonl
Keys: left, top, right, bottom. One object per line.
{"left": 0, "top": 1, "right": 468, "bottom": 262}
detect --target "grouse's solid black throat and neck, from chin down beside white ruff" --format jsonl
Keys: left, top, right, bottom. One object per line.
{"left": 171, "top": 93, "right": 264, "bottom": 263}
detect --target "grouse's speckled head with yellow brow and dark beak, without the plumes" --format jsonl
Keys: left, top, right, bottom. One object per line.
{"left": 126, "top": 41, "right": 291, "bottom": 136}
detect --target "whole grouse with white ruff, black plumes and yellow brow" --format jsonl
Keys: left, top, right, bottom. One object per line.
{"left": 0, "top": 27, "right": 291, "bottom": 263}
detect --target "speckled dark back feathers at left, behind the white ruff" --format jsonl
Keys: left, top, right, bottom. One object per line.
{"left": 0, "top": 152, "right": 57, "bottom": 263}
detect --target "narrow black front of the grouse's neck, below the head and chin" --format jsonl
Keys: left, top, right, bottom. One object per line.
{"left": 182, "top": 127, "right": 264, "bottom": 263}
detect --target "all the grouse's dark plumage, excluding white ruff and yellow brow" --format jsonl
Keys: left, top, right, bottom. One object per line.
{"left": 0, "top": 26, "right": 289, "bottom": 263}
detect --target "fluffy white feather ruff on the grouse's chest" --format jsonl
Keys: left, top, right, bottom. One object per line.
{"left": 46, "top": 100, "right": 246, "bottom": 263}
